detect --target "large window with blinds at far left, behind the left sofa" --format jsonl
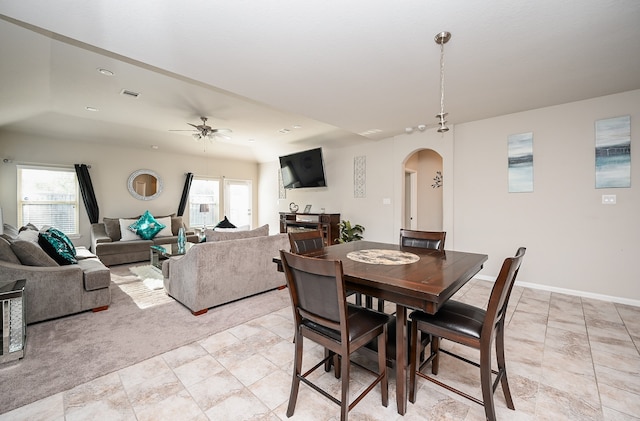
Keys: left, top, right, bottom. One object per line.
{"left": 18, "top": 166, "right": 79, "bottom": 235}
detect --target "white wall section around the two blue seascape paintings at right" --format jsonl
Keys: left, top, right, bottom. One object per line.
{"left": 447, "top": 91, "right": 640, "bottom": 303}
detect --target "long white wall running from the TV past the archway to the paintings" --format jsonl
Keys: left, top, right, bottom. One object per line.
{"left": 273, "top": 91, "right": 640, "bottom": 305}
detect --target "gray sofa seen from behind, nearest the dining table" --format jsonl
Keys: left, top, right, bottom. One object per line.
{"left": 162, "top": 225, "right": 289, "bottom": 315}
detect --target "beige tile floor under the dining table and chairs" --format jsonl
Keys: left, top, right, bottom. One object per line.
{"left": 0, "top": 280, "right": 640, "bottom": 421}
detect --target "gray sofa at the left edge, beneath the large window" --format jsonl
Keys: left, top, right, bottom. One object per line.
{"left": 0, "top": 231, "right": 111, "bottom": 324}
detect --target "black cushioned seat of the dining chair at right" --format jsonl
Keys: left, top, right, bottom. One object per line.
{"left": 409, "top": 300, "right": 486, "bottom": 339}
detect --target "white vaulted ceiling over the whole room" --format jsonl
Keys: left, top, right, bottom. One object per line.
{"left": 0, "top": 0, "right": 640, "bottom": 162}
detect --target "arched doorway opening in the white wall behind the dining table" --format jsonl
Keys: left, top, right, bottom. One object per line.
{"left": 402, "top": 149, "right": 443, "bottom": 231}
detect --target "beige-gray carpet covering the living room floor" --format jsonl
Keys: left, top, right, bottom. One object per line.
{"left": 0, "top": 265, "right": 289, "bottom": 413}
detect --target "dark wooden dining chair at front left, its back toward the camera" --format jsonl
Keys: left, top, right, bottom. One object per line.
{"left": 280, "top": 250, "right": 389, "bottom": 421}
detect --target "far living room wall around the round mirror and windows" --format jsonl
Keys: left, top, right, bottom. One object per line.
{"left": 0, "top": 132, "right": 258, "bottom": 246}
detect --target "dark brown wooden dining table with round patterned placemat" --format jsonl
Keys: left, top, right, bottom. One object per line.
{"left": 274, "top": 240, "right": 488, "bottom": 415}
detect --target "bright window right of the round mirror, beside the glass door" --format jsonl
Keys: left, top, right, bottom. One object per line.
{"left": 189, "top": 177, "right": 220, "bottom": 228}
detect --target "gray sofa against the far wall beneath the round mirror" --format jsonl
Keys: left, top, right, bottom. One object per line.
{"left": 91, "top": 214, "right": 199, "bottom": 266}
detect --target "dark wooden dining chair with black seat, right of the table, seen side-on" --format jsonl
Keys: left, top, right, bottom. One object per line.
{"left": 409, "top": 247, "right": 526, "bottom": 421}
